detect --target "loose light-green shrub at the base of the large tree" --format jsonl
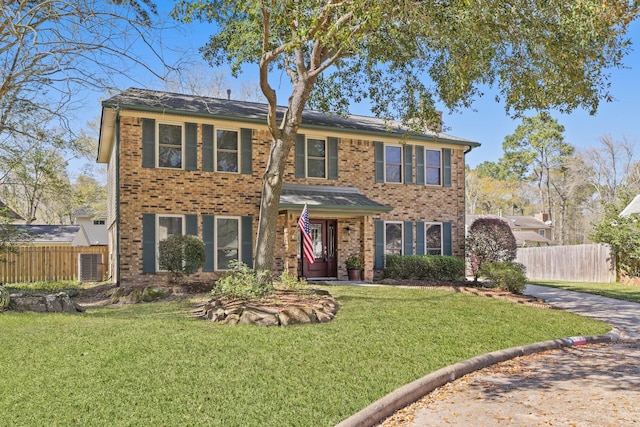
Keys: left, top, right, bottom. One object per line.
{"left": 211, "top": 261, "right": 274, "bottom": 299}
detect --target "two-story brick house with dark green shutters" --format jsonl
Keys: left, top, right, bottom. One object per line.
{"left": 97, "top": 89, "right": 480, "bottom": 285}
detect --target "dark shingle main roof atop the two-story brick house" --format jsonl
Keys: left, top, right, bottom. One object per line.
{"left": 102, "top": 88, "right": 480, "bottom": 147}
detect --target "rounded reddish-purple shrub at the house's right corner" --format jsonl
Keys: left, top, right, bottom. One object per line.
{"left": 465, "top": 218, "right": 518, "bottom": 280}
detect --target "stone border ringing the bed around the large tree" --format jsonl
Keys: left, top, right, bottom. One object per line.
{"left": 193, "top": 289, "right": 338, "bottom": 326}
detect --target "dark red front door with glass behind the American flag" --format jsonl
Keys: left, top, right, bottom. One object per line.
{"left": 298, "top": 219, "right": 338, "bottom": 278}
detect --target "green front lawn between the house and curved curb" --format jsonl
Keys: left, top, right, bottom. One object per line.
{"left": 0, "top": 287, "right": 610, "bottom": 426}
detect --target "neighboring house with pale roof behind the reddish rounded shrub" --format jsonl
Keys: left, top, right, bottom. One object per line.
{"left": 466, "top": 214, "right": 553, "bottom": 248}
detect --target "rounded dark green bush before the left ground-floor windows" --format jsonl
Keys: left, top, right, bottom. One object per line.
{"left": 158, "top": 234, "right": 205, "bottom": 281}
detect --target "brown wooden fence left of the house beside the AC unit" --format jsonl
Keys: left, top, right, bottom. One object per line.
{"left": 0, "top": 246, "right": 109, "bottom": 283}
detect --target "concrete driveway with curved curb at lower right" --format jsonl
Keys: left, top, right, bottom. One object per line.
{"left": 339, "top": 285, "right": 640, "bottom": 427}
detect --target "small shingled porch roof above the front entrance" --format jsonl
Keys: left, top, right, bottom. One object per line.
{"left": 280, "top": 184, "right": 393, "bottom": 216}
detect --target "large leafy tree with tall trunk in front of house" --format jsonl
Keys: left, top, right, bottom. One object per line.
{"left": 173, "top": 0, "right": 638, "bottom": 278}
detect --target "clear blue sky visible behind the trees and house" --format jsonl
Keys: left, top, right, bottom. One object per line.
{"left": 86, "top": 2, "right": 640, "bottom": 168}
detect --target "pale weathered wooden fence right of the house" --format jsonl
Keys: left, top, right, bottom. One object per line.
{"left": 516, "top": 244, "right": 616, "bottom": 283}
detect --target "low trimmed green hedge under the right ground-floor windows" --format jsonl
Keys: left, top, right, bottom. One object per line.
{"left": 384, "top": 255, "right": 465, "bottom": 282}
